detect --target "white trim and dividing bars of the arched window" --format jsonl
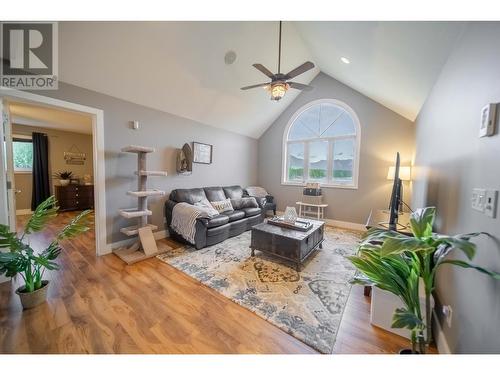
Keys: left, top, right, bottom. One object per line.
{"left": 281, "top": 99, "right": 361, "bottom": 189}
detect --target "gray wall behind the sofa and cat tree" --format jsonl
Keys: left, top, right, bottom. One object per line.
{"left": 35, "top": 83, "right": 257, "bottom": 243}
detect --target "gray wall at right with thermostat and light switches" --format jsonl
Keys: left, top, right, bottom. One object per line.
{"left": 413, "top": 23, "right": 500, "bottom": 353}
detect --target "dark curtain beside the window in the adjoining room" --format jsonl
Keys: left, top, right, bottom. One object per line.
{"left": 31, "top": 133, "right": 50, "bottom": 211}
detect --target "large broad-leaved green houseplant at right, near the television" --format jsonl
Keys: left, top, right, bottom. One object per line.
{"left": 351, "top": 207, "right": 500, "bottom": 354}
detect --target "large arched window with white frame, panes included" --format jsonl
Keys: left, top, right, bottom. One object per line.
{"left": 282, "top": 99, "right": 361, "bottom": 188}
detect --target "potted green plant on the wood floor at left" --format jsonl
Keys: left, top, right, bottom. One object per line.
{"left": 0, "top": 196, "right": 91, "bottom": 309}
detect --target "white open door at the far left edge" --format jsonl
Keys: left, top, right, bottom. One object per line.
{"left": 0, "top": 99, "right": 16, "bottom": 231}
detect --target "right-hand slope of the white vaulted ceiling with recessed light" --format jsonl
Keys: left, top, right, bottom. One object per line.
{"left": 296, "top": 22, "right": 466, "bottom": 121}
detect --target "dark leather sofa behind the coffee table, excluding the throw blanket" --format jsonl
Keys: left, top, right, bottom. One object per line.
{"left": 165, "top": 186, "right": 266, "bottom": 249}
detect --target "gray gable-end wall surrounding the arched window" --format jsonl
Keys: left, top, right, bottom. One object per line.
{"left": 258, "top": 73, "right": 414, "bottom": 223}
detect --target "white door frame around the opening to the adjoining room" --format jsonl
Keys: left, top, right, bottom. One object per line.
{"left": 0, "top": 87, "right": 109, "bottom": 255}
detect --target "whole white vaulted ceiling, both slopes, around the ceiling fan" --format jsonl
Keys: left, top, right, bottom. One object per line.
{"left": 59, "top": 22, "right": 464, "bottom": 138}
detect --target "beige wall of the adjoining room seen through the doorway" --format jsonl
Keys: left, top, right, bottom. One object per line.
{"left": 12, "top": 124, "right": 93, "bottom": 210}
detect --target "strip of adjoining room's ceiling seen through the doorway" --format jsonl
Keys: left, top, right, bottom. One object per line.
{"left": 9, "top": 102, "right": 92, "bottom": 134}
